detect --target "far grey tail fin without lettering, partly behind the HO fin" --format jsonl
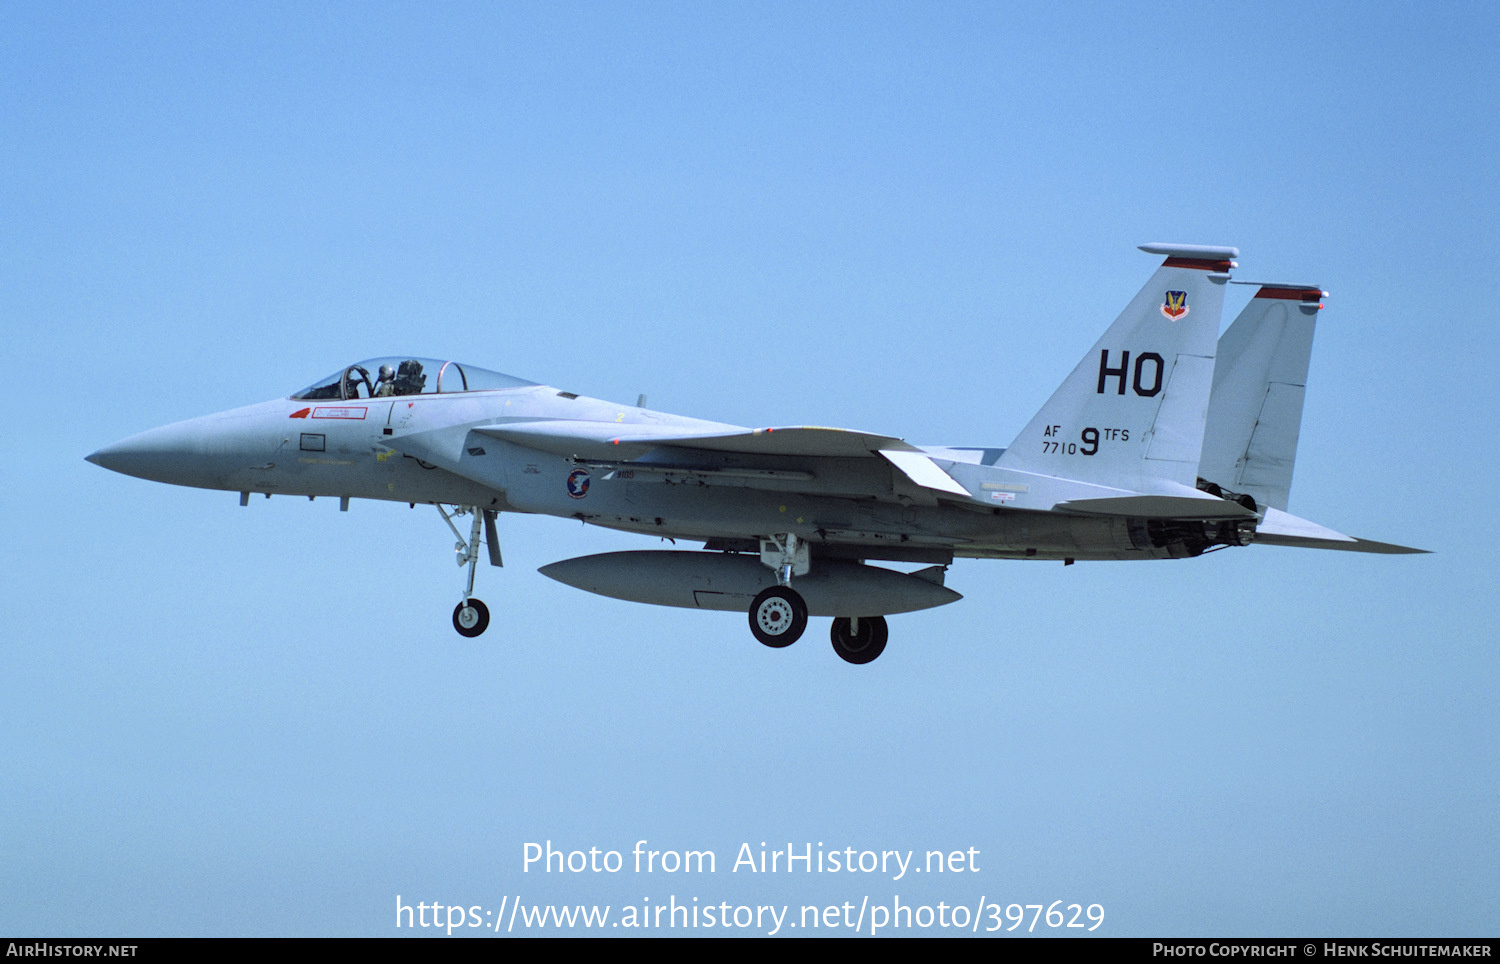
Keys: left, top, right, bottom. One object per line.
{"left": 1199, "top": 285, "right": 1328, "bottom": 511}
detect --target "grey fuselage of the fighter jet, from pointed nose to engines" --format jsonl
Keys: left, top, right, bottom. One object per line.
{"left": 89, "top": 360, "right": 1236, "bottom": 562}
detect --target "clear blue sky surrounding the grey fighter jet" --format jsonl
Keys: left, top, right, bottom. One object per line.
{"left": 0, "top": 3, "right": 1500, "bottom": 936}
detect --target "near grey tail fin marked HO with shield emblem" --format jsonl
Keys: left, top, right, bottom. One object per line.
{"left": 998, "top": 244, "right": 1239, "bottom": 490}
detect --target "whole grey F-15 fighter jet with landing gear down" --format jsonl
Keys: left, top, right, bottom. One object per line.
{"left": 89, "top": 244, "right": 1422, "bottom": 663}
